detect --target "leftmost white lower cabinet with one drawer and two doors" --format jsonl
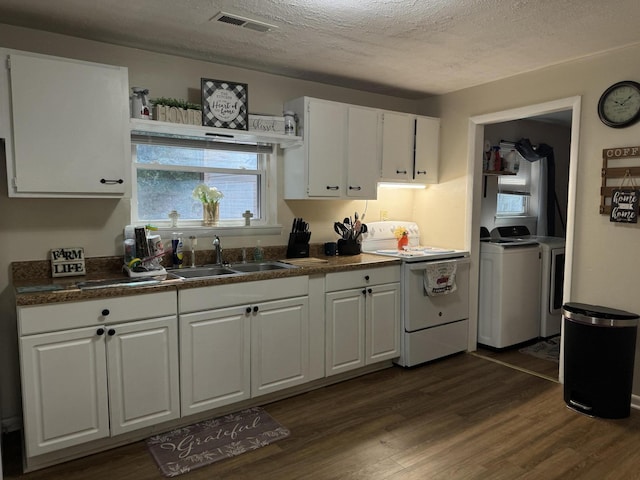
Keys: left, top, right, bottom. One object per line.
{"left": 18, "top": 292, "right": 180, "bottom": 457}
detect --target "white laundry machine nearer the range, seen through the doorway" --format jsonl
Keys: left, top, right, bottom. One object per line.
{"left": 478, "top": 239, "right": 542, "bottom": 348}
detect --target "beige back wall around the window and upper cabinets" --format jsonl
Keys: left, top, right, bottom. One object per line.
{"left": 0, "top": 24, "right": 416, "bottom": 428}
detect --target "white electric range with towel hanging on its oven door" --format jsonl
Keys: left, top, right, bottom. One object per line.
{"left": 362, "top": 221, "right": 469, "bottom": 367}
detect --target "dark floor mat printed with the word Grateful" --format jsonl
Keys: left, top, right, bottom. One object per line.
{"left": 147, "top": 407, "right": 289, "bottom": 477}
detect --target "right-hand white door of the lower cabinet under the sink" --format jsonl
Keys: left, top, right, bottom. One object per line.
{"left": 251, "top": 297, "right": 309, "bottom": 397}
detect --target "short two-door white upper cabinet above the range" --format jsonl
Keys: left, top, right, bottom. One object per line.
{"left": 380, "top": 112, "right": 440, "bottom": 184}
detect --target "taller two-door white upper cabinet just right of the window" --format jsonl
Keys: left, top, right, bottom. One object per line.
{"left": 284, "top": 97, "right": 380, "bottom": 199}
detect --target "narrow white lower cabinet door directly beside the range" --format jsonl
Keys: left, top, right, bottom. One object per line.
{"left": 365, "top": 283, "right": 400, "bottom": 365}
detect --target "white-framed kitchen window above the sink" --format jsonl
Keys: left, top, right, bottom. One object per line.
{"left": 131, "top": 135, "right": 276, "bottom": 228}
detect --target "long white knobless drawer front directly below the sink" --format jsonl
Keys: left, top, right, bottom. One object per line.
{"left": 178, "top": 277, "right": 309, "bottom": 313}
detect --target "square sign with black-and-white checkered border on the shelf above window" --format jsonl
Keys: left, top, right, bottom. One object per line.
{"left": 201, "top": 78, "right": 249, "bottom": 130}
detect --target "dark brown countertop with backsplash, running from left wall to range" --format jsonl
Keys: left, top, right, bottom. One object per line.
{"left": 12, "top": 247, "right": 400, "bottom": 306}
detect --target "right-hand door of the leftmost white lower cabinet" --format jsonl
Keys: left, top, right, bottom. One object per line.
{"left": 107, "top": 316, "right": 180, "bottom": 435}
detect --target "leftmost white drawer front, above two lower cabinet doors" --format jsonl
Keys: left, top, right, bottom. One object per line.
{"left": 18, "top": 292, "right": 177, "bottom": 336}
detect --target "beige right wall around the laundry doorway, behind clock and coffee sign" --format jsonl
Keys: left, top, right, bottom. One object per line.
{"left": 421, "top": 42, "right": 640, "bottom": 394}
